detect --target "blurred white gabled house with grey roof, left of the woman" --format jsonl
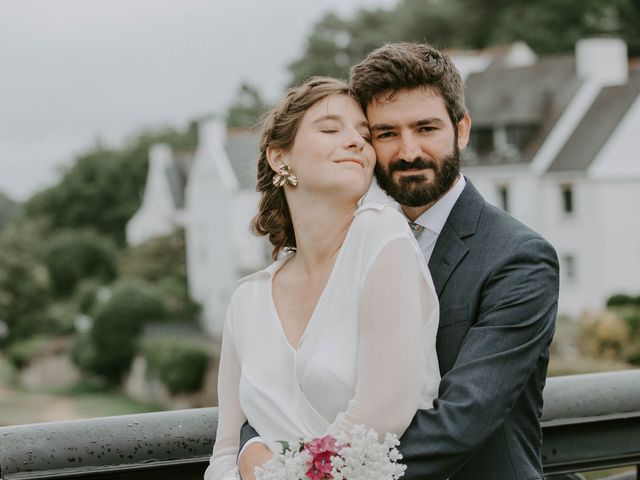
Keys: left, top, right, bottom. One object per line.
{"left": 127, "top": 118, "right": 269, "bottom": 335}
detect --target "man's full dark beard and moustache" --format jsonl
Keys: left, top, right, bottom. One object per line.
{"left": 374, "top": 142, "right": 460, "bottom": 207}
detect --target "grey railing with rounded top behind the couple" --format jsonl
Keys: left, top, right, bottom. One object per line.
{"left": 0, "top": 370, "right": 640, "bottom": 480}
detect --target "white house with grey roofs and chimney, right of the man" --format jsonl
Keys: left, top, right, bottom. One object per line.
{"left": 462, "top": 38, "right": 640, "bottom": 316}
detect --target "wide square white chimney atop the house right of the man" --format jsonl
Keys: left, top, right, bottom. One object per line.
{"left": 576, "top": 38, "right": 629, "bottom": 87}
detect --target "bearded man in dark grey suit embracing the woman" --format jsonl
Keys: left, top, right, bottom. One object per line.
{"left": 239, "top": 43, "right": 558, "bottom": 480}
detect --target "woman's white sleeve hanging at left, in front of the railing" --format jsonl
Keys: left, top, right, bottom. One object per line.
{"left": 204, "top": 314, "right": 246, "bottom": 480}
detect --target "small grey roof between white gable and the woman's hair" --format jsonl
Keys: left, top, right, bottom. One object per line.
{"left": 225, "top": 129, "right": 260, "bottom": 190}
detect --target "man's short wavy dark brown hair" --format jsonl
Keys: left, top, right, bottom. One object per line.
{"left": 349, "top": 43, "right": 467, "bottom": 125}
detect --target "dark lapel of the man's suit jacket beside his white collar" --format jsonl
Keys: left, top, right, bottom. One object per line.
{"left": 429, "top": 177, "right": 484, "bottom": 297}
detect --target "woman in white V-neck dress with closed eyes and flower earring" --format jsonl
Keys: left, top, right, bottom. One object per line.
{"left": 205, "top": 77, "right": 439, "bottom": 480}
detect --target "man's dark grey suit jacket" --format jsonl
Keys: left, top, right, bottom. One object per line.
{"left": 400, "top": 179, "right": 558, "bottom": 480}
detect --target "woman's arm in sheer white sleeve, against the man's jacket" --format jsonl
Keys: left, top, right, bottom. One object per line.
{"left": 328, "top": 236, "right": 439, "bottom": 436}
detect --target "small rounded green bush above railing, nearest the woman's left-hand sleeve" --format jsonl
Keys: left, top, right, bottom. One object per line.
{"left": 142, "top": 338, "right": 211, "bottom": 394}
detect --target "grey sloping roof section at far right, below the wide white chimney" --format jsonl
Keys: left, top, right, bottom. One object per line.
{"left": 548, "top": 72, "right": 640, "bottom": 172}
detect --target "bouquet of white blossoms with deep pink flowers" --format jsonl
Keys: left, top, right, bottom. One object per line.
{"left": 256, "top": 425, "right": 407, "bottom": 480}
